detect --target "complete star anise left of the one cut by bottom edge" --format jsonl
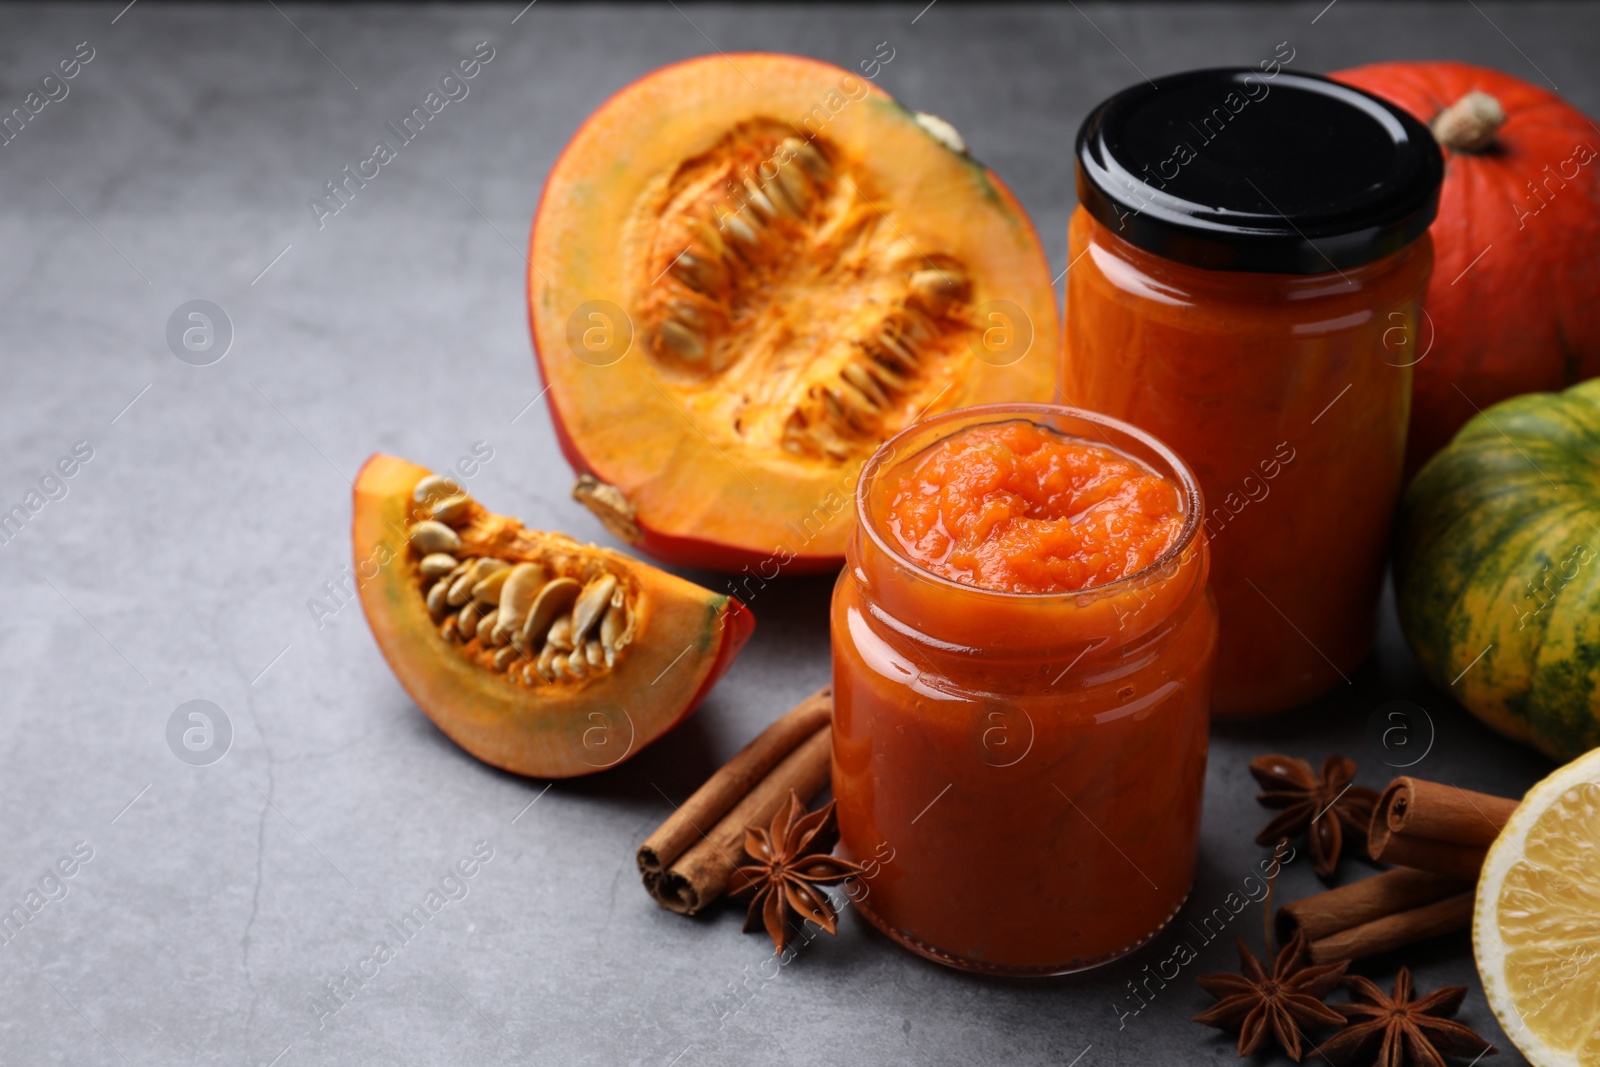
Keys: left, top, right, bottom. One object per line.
{"left": 1195, "top": 934, "right": 1350, "bottom": 1062}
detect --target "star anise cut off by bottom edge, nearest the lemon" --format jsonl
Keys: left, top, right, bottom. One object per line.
{"left": 1322, "top": 968, "right": 1499, "bottom": 1067}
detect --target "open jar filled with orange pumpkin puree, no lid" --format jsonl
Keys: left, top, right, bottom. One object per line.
{"left": 832, "top": 405, "right": 1216, "bottom": 976}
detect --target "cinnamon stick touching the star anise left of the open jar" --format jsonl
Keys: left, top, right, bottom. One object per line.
{"left": 645, "top": 726, "right": 834, "bottom": 915}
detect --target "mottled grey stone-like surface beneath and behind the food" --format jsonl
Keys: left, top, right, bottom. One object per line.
{"left": 0, "top": 0, "right": 1580, "bottom": 1067}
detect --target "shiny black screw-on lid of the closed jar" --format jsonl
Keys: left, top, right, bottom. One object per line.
{"left": 1077, "top": 67, "right": 1445, "bottom": 274}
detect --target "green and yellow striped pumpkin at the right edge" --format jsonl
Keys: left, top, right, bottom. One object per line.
{"left": 1395, "top": 379, "right": 1600, "bottom": 761}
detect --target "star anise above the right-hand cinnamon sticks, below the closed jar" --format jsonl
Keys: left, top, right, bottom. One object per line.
{"left": 1250, "top": 755, "right": 1378, "bottom": 878}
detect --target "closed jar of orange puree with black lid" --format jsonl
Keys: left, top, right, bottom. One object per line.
{"left": 1061, "top": 67, "right": 1443, "bottom": 717}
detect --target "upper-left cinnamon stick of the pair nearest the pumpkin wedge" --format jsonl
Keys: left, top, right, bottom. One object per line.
{"left": 637, "top": 685, "right": 834, "bottom": 881}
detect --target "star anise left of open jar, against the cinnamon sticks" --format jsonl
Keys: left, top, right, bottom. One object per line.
{"left": 730, "top": 790, "right": 862, "bottom": 952}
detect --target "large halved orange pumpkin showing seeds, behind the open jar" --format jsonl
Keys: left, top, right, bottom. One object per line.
{"left": 528, "top": 53, "right": 1061, "bottom": 577}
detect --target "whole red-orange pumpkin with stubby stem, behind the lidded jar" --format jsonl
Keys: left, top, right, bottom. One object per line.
{"left": 1331, "top": 62, "right": 1600, "bottom": 477}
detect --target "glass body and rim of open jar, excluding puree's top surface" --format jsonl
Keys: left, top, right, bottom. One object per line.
{"left": 832, "top": 405, "right": 1216, "bottom": 976}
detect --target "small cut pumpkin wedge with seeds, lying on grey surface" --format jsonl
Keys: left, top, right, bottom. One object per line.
{"left": 352, "top": 454, "right": 755, "bottom": 777}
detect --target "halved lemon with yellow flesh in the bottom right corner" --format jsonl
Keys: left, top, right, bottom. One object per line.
{"left": 1472, "top": 749, "right": 1600, "bottom": 1067}
